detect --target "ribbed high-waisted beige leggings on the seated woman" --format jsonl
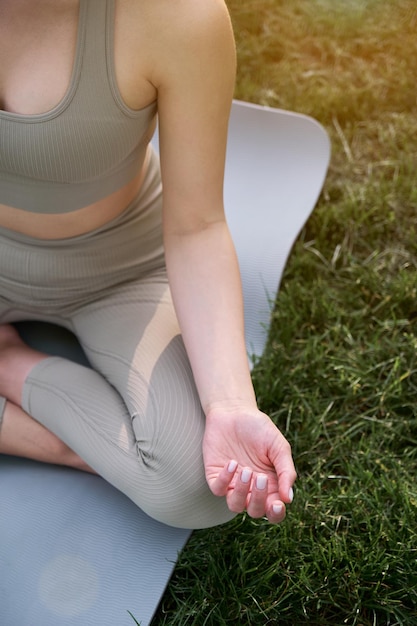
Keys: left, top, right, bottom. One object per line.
{"left": 0, "top": 150, "right": 233, "bottom": 528}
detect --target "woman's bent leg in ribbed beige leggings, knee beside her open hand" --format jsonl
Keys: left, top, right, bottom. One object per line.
{"left": 16, "top": 272, "right": 233, "bottom": 528}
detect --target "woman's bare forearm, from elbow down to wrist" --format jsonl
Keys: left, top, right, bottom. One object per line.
{"left": 165, "top": 221, "right": 256, "bottom": 414}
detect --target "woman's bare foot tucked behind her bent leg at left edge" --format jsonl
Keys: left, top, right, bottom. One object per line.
{"left": 0, "top": 324, "right": 47, "bottom": 406}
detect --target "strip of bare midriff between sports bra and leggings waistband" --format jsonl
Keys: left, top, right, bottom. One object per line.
{"left": 0, "top": 148, "right": 149, "bottom": 239}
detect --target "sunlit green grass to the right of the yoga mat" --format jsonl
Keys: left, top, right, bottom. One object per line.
{"left": 146, "top": 0, "right": 417, "bottom": 626}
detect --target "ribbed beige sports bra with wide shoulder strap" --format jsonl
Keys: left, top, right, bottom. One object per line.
{"left": 0, "top": 0, "right": 157, "bottom": 214}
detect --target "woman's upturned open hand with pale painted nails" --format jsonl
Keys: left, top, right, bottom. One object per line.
{"left": 203, "top": 409, "right": 296, "bottom": 523}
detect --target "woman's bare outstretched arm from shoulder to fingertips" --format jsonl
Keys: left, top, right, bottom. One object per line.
{"left": 152, "top": 0, "right": 295, "bottom": 522}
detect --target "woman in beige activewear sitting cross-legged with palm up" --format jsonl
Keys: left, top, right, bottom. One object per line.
{"left": 0, "top": 0, "right": 295, "bottom": 528}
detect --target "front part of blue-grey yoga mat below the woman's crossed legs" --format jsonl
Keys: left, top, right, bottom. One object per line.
{"left": 0, "top": 457, "right": 189, "bottom": 626}
